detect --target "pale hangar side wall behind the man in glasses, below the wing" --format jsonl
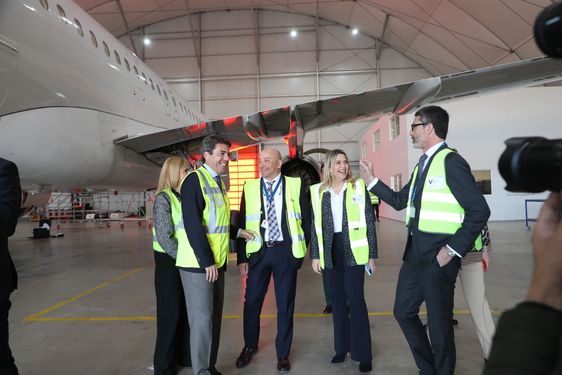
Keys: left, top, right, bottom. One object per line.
{"left": 361, "top": 87, "right": 562, "bottom": 221}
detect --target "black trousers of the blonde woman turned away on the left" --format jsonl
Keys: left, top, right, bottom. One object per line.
{"left": 154, "top": 251, "right": 191, "bottom": 375}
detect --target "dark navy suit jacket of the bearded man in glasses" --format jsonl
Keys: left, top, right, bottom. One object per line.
{"left": 371, "top": 145, "right": 490, "bottom": 264}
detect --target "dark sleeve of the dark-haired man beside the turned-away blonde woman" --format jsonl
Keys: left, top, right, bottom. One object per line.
{"left": 180, "top": 172, "right": 215, "bottom": 268}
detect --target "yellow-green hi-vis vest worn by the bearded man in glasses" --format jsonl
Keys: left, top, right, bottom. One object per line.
{"left": 406, "top": 148, "right": 482, "bottom": 250}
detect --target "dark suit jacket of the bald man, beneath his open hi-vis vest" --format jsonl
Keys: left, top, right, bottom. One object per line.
{"left": 237, "top": 176, "right": 311, "bottom": 267}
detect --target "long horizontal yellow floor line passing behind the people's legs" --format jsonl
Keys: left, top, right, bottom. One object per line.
{"left": 25, "top": 310, "right": 501, "bottom": 322}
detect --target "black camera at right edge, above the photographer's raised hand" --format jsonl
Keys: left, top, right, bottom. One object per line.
{"left": 498, "top": 137, "right": 562, "bottom": 193}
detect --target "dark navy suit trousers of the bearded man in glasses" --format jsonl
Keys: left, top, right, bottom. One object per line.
{"left": 394, "top": 259, "right": 460, "bottom": 375}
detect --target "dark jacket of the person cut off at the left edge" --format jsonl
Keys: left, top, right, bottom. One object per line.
{"left": 0, "top": 158, "right": 21, "bottom": 294}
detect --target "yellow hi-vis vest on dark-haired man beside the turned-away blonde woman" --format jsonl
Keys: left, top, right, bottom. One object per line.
{"left": 176, "top": 167, "right": 230, "bottom": 268}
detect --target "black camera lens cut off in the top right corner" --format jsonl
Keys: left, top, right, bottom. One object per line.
{"left": 535, "top": 3, "right": 562, "bottom": 57}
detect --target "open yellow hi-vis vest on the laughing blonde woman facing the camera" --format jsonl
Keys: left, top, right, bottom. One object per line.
{"left": 310, "top": 179, "right": 369, "bottom": 269}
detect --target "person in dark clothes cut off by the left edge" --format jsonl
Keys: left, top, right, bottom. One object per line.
{"left": 0, "top": 158, "right": 21, "bottom": 375}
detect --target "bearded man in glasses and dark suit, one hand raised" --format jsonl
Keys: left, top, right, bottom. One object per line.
{"left": 361, "top": 106, "right": 490, "bottom": 375}
